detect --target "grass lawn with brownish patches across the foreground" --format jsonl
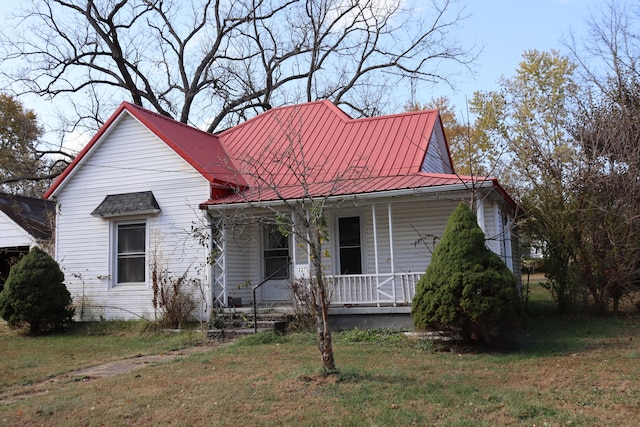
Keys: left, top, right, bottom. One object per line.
{"left": 0, "top": 285, "right": 640, "bottom": 426}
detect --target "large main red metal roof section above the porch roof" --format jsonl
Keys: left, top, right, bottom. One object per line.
{"left": 219, "top": 101, "right": 438, "bottom": 186}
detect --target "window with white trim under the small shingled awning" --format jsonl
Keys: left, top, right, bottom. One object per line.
{"left": 114, "top": 221, "right": 147, "bottom": 284}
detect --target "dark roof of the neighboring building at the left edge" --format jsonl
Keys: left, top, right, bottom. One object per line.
{"left": 0, "top": 192, "right": 55, "bottom": 240}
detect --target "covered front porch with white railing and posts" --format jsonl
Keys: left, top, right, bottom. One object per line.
{"left": 209, "top": 189, "right": 513, "bottom": 311}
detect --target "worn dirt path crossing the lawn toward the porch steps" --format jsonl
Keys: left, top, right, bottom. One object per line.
{"left": 0, "top": 342, "right": 224, "bottom": 405}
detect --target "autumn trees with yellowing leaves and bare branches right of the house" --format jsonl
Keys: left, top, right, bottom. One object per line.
{"left": 420, "top": 1, "right": 640, "bottom": 313}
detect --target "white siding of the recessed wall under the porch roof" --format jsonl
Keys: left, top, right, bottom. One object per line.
{"left": 222, "top": 195, "right": 466, "bottom": 292}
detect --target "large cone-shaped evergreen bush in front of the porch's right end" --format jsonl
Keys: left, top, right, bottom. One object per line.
{"left": 412, "top": 203, "right": 523, "bottom": 344}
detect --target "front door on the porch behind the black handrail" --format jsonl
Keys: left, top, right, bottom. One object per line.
{"left": 262, "top": 224, "right": 291, "bottom": 302}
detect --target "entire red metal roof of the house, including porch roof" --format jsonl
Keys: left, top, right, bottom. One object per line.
{"left": 45, "top": 101, "right": 508, "bottom": 205}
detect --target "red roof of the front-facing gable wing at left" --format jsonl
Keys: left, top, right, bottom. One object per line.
{"left": 44, "top": 102, "right": 246, "bottom": 199}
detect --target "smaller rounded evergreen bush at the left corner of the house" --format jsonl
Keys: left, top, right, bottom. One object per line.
{"left": 0, "top": 248, "right": 74, "bottom": 335}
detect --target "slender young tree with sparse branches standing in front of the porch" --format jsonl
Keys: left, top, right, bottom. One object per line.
{"left": 211, "top": 111, "right": 371, "bottom": 373}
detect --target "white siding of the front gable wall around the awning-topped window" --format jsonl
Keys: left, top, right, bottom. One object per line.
{"left": 56, "top": 114, "right": 208, "bottom": 318}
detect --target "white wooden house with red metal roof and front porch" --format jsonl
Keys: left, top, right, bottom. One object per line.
{"left": 45, "top": 101, "right": 520, "bottom": 318}
